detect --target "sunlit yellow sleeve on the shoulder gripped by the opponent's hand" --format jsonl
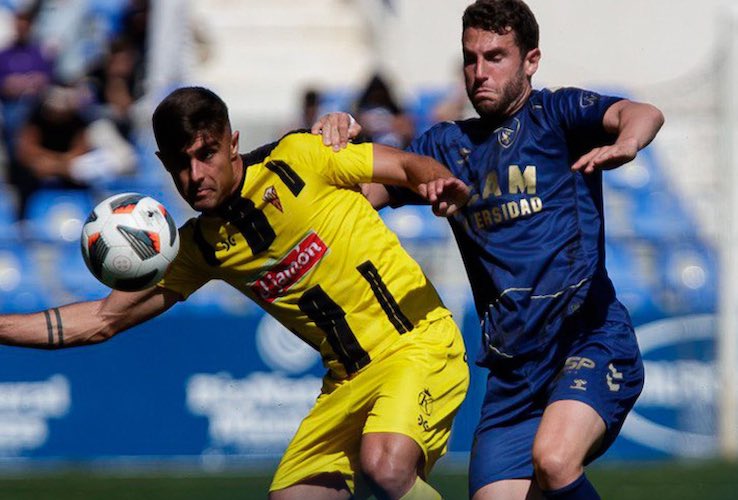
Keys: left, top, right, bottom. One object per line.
{"left": 280, "top": 133, "right": 374, "bottom": 187}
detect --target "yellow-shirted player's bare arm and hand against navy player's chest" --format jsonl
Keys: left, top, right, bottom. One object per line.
{"left": 370, "top": 144, "right": 469, "bottom": 217}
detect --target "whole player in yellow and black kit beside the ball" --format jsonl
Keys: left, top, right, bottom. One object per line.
{"left": 0, "top": 87, "right": 469, "bottom": 500}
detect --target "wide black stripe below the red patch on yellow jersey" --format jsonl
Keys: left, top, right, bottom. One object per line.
{"left": 297, "top": 285, "right": 371, "bottom": 374}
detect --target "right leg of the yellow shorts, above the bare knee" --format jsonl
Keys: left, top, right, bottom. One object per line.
{"left": 363, "top": 318, "right": 469, "bottom": 476}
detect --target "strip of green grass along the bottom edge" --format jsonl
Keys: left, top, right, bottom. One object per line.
{"left": 0, "top": 462, "right": 738, "bottom": 500}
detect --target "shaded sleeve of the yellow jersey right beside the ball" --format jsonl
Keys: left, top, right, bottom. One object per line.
{"left": 157, "top": 219, "right": 212, "bottom": 300}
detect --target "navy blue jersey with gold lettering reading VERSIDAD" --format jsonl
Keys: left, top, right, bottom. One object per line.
{"left": 390, "top": 88, "right": 627, "bottom": 365}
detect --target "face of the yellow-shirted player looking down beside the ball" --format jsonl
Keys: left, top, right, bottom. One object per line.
{"left": 156, "top": 131, "right": 243, "bottom": 213}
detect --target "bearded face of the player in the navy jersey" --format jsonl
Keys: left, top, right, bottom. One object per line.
{"left": 462, "top": 28, "right": 541, "bottom": 118}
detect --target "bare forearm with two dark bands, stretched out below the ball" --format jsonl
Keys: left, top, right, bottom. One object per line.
{"left": 0, "top": 287, "right": 178, "bottom": 349}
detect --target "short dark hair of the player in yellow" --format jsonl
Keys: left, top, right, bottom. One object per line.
{"left": 151, "top": 87, "right": 231, "bottom": 152}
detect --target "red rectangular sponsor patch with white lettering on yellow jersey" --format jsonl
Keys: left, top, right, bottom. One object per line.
{"left": 249, "top": 232, "right": 328, "bottom": 302}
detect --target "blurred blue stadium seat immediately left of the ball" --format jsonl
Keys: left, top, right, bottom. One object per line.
{"left": 24, "top": 189, "right": 95, "bottom": 242}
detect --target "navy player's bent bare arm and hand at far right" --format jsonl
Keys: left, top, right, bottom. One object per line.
{"left": 571, "top": 100, "right": 664, "bottom": 174}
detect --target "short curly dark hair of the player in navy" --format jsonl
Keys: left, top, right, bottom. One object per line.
{"left": 461, "top": 0, "right": 539, "bottom": 54}
